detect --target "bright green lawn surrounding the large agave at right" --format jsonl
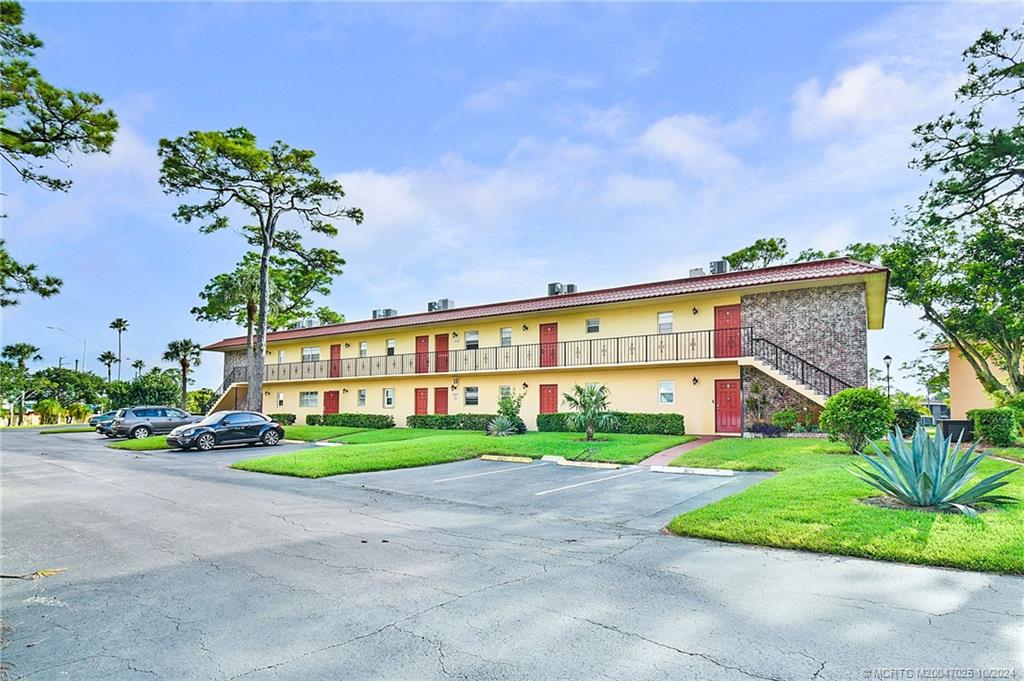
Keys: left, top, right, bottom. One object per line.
{"left": 669, "top": 439, "right": 1024, "bottom": 573}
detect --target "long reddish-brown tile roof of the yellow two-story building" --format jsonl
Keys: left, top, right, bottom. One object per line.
{"left": 203, "top": 258, "right": 887, "bottom": 350}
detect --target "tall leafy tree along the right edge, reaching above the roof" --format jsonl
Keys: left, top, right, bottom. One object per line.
{"left": 882, "top": 22, "right": 1024, "bottom": 395}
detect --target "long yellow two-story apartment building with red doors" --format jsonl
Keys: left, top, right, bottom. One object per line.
{"left": 204, "top": 258, "right": 888, "bottom": 434}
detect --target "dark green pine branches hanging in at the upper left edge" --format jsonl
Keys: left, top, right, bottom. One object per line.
{"left": 0, "top": 0, "right": 118, "bottom": 307}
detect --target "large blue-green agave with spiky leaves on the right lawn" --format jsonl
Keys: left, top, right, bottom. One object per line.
{"left": 850, "top": 425, "right": 1018, "bottom": 516}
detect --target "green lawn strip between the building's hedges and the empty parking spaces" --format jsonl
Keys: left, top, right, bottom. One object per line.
{"left": 232, "top": 429, "right": 694, "bottom": 477}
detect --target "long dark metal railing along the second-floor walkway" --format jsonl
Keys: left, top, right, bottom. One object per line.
{"left": 251, "top": 328, "right": 752, "bottom": 381}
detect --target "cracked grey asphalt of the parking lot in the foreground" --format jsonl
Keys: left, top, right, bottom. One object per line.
{"left": 0, "top": 431, "right": 1024, "bottom": 681}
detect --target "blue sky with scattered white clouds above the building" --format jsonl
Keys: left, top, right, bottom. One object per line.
{"left": 3, "top": 3, "right": 1020, "bottom": 387}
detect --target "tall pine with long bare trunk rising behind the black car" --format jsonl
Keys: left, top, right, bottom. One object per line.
{"left": 160, "top": 128, "right": 362, "bottom": 411}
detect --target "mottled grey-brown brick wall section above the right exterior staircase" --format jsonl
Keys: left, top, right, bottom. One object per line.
{"left": 740, "top": 284, "right": 867, "bottom": 385}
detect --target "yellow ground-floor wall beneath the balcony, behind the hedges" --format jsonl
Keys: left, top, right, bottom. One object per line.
{"left": 254, "top": 363, "right": 739, "bottom": 433}
